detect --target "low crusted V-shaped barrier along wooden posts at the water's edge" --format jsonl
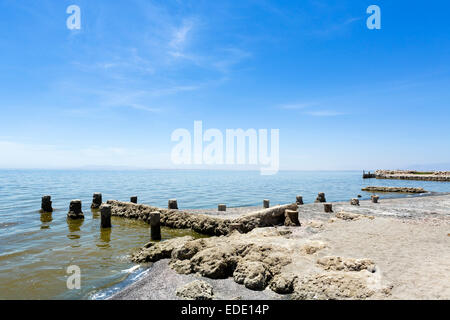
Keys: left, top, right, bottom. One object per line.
{"left": 107, "top": 200, "right": 297, "bottom": 236}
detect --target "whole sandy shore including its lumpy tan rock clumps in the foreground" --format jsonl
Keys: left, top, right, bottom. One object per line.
{"left": 111, "top": 194, "right": 450, "bottom": 299}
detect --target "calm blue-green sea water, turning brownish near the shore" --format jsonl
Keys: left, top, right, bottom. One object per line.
{"left": 0, "top": 170, "right": 450, "bottom": 299}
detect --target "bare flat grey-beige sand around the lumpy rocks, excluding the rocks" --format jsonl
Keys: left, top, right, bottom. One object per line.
{"left": 111, "top": 195, "right": 450, "bottom": 299}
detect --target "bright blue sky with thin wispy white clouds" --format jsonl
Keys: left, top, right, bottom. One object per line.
{"left": 0, "top": 0, "right": 450, "bottom": 170}
